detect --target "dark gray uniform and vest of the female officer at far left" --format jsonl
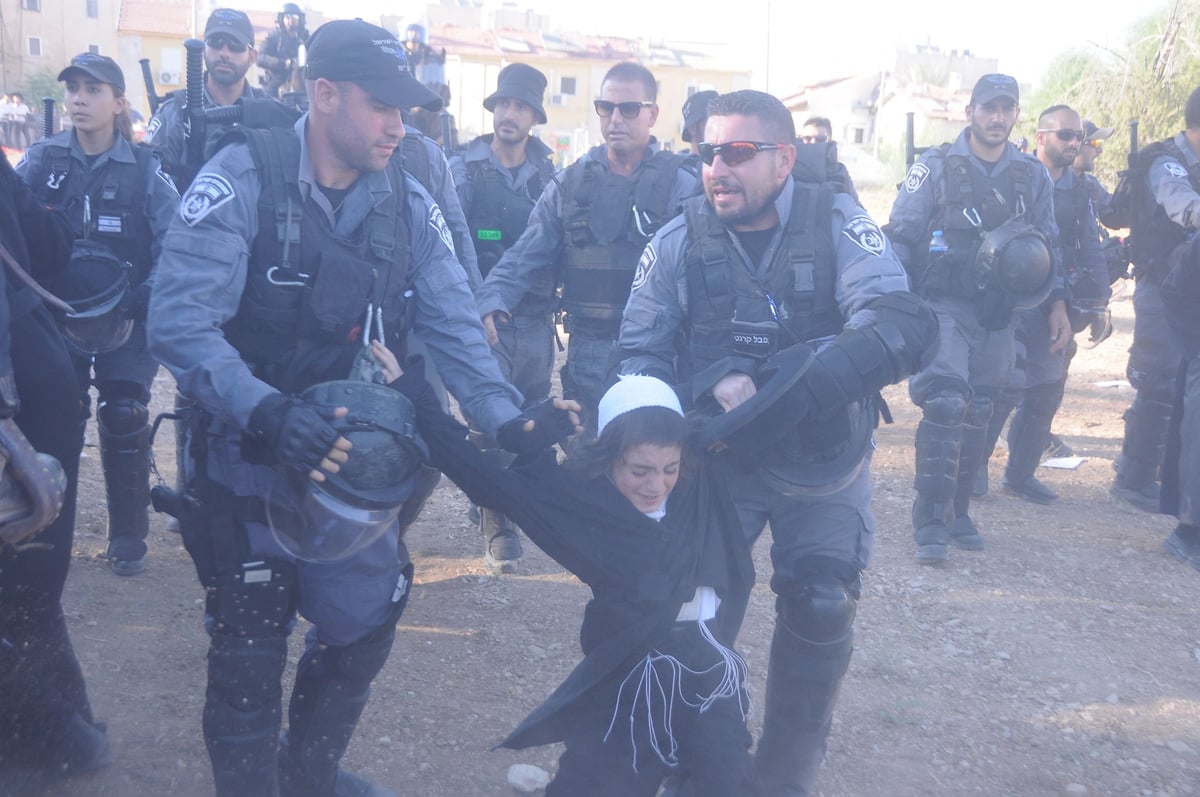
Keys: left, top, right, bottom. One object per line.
{"left": 17, "top": 131, "right": 179, "bottom": 562}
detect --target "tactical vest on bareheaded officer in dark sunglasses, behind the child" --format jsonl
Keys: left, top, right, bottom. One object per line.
{"left": 562, "top": 146, "right": 683, "bottom": 337}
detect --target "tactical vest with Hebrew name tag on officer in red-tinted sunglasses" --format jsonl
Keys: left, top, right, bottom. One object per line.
{"left": 684, "top": 181, "right": 845, "bottom": 371}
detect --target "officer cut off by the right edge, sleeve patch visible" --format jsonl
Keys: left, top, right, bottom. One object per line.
{"left": 1111, "top": 89, "right": 1200, "bottom": 511}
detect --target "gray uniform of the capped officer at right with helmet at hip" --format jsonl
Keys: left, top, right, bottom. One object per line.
{"left": 884, "top": 128, "right": 1063, "bottom": 561}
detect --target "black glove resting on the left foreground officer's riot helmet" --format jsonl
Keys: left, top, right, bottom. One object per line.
{"left": 246, "top": 392, "right": 338, "bottom": 473}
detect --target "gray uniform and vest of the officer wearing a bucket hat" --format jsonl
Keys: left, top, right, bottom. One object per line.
{"left": 450, "top": 134, "right": 556, "bottom": 402}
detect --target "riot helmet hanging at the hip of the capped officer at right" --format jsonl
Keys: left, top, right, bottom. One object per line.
{"left": 974, "top": 221, "right": 1054, "bottom": 310}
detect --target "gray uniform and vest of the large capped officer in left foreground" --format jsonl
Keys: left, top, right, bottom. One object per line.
{"left": 149, "top": 116, "right": 521, "bottom": 795}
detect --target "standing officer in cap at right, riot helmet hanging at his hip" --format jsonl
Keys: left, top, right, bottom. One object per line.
{"left": 887, "top": 74, "right": 1070, "bottom": 564}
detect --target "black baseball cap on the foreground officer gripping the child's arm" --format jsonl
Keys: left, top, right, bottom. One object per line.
{"left": 305, "top": 19, "right": 442, "bottom": 110}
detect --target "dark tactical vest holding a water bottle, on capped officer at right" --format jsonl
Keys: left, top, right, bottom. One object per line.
{"left": 913, "top": 144, "right": 1033, "bottom": 299}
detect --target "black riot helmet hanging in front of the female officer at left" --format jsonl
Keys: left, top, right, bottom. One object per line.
{"left": 49, "top": 240, "right": 133, "bottom": 354}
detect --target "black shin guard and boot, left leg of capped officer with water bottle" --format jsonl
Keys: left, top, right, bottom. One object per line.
{"left": 912, "top": 396, "right": 962, "bottom": 564}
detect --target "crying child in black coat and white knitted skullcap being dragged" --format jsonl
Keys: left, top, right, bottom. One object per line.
{"left": 374, "top": 344, "right": 757, "bottom": 797}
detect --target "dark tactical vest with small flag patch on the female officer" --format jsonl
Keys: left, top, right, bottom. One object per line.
{"left": 29, "top": 133, "right": 154, "bottom": 284}
